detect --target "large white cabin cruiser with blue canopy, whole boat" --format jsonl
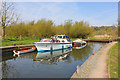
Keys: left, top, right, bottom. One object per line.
{"left": 34, "top": 35, "right": 72, "bottom": 52}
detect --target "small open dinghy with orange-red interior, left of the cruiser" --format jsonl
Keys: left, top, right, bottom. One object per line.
{"left": 13, "top": 47, "right": 36, "bottom": 56}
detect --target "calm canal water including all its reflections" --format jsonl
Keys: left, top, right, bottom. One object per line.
{"left": 1, "top": 43, "right": 105, "bottom": 78}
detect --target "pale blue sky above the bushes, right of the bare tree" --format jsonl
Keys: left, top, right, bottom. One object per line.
{"left": 16, "top": 2, "right": 118, "bottom": 26}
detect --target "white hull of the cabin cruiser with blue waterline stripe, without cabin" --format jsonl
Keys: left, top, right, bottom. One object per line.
{"left": 35, "top": 43, "right": 72, "bottom": 52}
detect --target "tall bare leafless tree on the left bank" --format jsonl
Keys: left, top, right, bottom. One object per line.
{"left": 0, "top": 2, "right": 19, "bottom": 40}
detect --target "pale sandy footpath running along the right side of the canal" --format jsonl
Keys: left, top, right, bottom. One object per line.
{"left": 71, "top": 42, "right": 117, "bottom": 78}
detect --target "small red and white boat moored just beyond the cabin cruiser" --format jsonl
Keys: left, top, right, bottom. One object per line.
{"left": 72, "top": 39, "right": 87, "bottom": 49}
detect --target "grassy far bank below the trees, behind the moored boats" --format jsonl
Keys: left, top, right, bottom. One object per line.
{"left": 0, "top": 36, "right": 118, "bottom": 47}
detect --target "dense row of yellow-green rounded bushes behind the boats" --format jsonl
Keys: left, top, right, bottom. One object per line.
{"left": 5, "top": 19, "right": 94, "bottom": 38}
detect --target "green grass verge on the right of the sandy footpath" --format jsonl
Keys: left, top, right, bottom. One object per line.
{"left": 107, "top": 43, "right": 118, "bottom": 78}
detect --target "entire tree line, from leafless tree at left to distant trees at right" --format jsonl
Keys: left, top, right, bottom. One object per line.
{"left": 0, "top": 2, "right": 117, "bottom": 40}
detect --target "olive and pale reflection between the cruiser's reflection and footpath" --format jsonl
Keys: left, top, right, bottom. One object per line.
{"left": 71, "top": 43, "right": 104, "bottom": 61}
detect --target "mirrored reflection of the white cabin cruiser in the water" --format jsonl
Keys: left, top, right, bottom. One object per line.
{"left": 33, "top": 49, "right": 72, "bottom": 64}
